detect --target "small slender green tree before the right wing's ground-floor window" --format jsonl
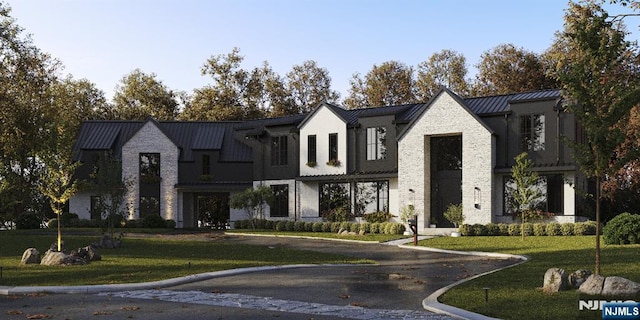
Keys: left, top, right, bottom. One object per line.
{"left": 507, "top": 152, "right": 544, "bottom": 239}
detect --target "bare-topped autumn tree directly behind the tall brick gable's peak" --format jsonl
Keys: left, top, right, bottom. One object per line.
{"left": 416, "top": 49, "right": 469, "bottom": 101}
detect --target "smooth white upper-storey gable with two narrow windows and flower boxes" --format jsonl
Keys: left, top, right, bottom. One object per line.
{"left": 298, "top": 103, "right": 348, "bottom": 176}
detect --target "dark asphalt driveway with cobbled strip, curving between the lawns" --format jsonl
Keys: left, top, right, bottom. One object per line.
{"left": 0, "top": 236, "right": 516, "bottom": 320}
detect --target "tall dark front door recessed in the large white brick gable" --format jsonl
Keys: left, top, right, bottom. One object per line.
{"left": 430, "top": 135, "right": 462, "bottom": 228}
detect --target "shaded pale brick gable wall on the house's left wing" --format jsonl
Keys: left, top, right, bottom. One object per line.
{"left": 122, "top": 121, "right": 180, "bottom": 223}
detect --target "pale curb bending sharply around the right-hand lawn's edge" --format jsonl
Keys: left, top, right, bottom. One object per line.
{"left": 398, "top": 245, "right": 529, "bottom": 320}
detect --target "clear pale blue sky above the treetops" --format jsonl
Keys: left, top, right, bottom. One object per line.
{"left": 7, "top": 0, "right": 640, "bottom": 99}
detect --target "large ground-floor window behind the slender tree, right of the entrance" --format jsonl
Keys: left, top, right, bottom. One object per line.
{"left": 503, "top": 174, "right": 564, "bottom": 215}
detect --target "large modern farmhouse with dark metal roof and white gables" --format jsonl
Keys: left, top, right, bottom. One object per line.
{"left": 70, "top": 89, "right": 586, "bottom": 232}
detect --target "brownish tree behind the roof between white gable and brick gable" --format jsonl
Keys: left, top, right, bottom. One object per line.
{"left": 344, "top": 61, "right": 416, "bottom": 109}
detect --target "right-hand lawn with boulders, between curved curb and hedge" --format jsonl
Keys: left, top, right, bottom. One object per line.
{"left": 420, "top": 236, "right": 640, "bottom": 320}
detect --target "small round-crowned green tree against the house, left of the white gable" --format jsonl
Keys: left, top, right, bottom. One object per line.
{"left": 229, "top": 185, "right": 274, "bottom": 229}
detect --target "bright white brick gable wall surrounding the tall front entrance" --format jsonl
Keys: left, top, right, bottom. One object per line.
{"left": 398, "top": 92, "right": 495, "bottom": 228}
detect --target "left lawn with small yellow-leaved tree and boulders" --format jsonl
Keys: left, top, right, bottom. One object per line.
{"left": 0, "top": 229, "right": 372, "bottom": 286}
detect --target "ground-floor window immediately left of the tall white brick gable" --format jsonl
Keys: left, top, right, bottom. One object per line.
{"left": 355, "top": 181, "right": 389, "bottom": 216}
